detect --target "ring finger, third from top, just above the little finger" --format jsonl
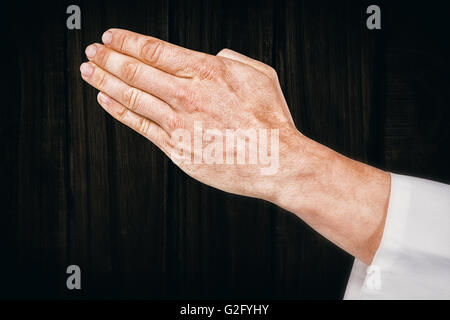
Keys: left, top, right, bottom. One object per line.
{"left": 80, "top": 62, "right": 177, "bottom": 132}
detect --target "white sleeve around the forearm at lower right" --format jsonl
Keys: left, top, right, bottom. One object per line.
{"left": 344, "top": 174, "right": 450, "bottom": 300}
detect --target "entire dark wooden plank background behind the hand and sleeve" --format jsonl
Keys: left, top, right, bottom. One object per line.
{"left": 0, "top": 0, "right": 450, "bottom": 299}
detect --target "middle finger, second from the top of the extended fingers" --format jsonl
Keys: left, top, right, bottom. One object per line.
{"left": 86, "top": 44, "right": 187, "bottom": 105}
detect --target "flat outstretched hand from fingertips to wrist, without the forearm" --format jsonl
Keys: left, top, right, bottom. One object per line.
{"left": 81, "top": 29, "right": 301, "bottom": 201}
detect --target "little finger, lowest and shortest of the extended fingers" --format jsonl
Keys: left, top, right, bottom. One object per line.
{"left": 97, "top": 92, "right": 171, "bottom": 154}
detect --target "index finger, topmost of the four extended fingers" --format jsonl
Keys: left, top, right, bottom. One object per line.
{"left": 102, "top": 29, "right": 213, "bottom": 78}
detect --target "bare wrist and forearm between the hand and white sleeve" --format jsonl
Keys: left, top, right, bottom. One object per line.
{"left": 270, "top": 135, "right": 390, "bottom": 264}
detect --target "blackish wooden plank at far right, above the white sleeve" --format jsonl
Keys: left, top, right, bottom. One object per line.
{"left": 383, "top": 3, "right": 450, "bottom": 183}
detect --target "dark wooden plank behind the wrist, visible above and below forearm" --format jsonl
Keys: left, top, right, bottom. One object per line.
{"left": 275, "top": 1, "right": 379, "bottom": 298}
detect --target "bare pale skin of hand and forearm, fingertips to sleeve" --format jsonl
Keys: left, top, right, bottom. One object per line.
{"left": 80, "top": 29, "right": 390, "bottom": 264}
